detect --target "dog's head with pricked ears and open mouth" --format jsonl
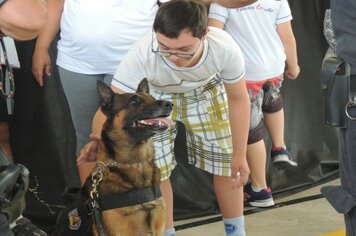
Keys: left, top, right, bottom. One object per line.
{"left": 98, "top": 79, "right": 173, "bottom": 143}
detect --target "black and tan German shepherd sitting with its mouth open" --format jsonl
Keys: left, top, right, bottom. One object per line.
{"left": 57, "top": 79, "right": 173, "bottom": 236}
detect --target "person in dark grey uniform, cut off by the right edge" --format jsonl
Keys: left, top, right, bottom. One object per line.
{"left": 321, "top": 0, "right": 356, "bottom": 236}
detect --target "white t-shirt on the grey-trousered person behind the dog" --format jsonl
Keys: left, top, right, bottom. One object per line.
{"left": 57, "top": 0, "right": 158, "bottom": 74}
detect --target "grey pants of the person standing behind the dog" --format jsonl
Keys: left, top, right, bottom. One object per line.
{"left": 58, "top": 67, "right": 113, "bottom": 155}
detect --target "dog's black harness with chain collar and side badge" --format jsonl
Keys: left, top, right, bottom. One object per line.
{"left": 56, "top": 162, "right": 161, "bottom": 236}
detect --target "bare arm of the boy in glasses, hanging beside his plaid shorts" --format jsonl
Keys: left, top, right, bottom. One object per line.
{"left": 224, "top": 79, "right": 250, "bottom": 186}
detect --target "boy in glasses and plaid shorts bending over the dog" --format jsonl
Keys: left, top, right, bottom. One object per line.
{"left": 78, "top": 0, "right": 250, "bottom": 236}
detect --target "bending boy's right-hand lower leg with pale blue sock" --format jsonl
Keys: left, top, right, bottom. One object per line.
{"left": 214, "top": 175, "right": 246, "bottom": 236}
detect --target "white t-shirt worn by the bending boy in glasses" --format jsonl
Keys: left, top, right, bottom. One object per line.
{"left": 112, "top": 28, "right": 245, "bottom": 93}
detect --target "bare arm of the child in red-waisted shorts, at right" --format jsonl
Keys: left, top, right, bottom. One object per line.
{"left": 277, "top": 21, "right": 300, "bottom": 79}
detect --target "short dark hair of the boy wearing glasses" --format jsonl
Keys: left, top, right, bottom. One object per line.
{"left": 153, "top": 0, "right": 208, "bottom": 38}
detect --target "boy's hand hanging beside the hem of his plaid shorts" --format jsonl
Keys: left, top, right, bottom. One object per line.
{"left": 231, "top": 157, "right": 250, "bottom": 188}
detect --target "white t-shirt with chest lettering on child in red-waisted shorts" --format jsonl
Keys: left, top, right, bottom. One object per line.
{"left": 209, "top": 0, "right": 292, "bottom": 81}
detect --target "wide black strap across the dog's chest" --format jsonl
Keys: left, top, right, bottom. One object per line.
{"left": 100, "top": 184, "right": 161, "bottom": 211}
